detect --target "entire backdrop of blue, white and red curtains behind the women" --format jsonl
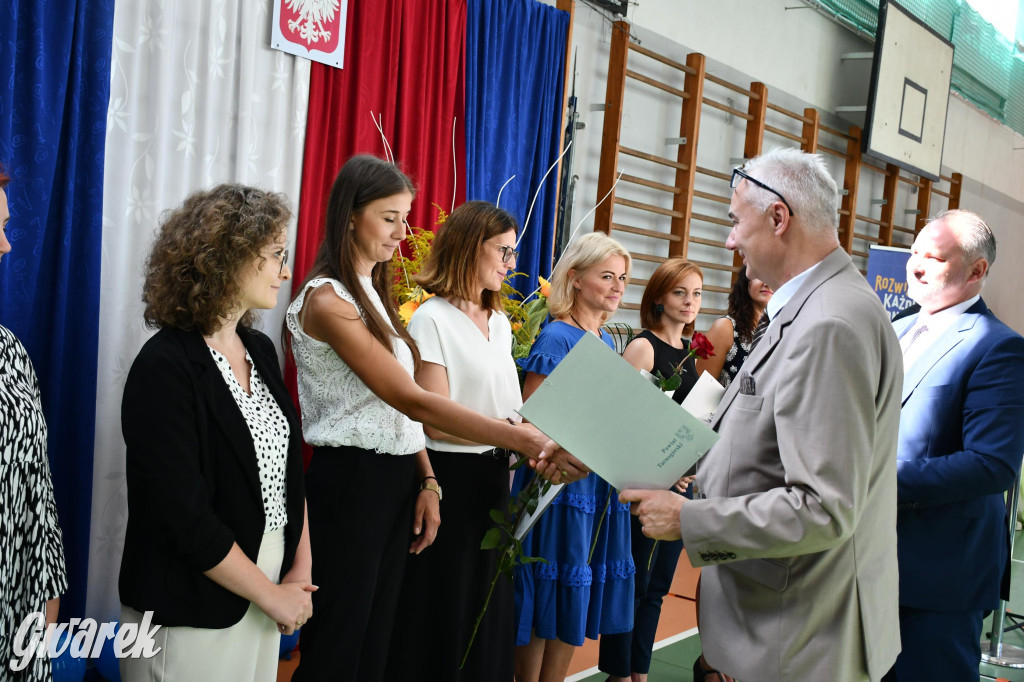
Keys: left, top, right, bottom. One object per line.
{"left": 0, "top": 0, "right": 568, "bottom": 620}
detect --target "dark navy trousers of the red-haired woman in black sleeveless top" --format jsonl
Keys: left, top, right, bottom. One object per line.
{"left": 598, "top": 509, "right": 683, "bottom": 677}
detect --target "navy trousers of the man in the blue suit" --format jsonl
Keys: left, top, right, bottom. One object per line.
{"left": 882, "top": 606, "right": 985, "bottom": 682}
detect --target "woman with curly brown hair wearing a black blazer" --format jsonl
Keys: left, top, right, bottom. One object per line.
{"left": 119, "top": 184, "right": 307, "bottom": 682}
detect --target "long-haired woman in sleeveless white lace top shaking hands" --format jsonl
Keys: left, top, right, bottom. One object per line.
{"left": 286, "top": 156, "right": 584, "bottom": 682}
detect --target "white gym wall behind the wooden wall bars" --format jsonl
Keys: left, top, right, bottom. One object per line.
{"left": 545, "top": 0, "right": 1024, "bottom": 332}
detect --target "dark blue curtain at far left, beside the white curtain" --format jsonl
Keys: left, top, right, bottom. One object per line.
{"left": 0, "top": 0, "right": 114, "bottom": 614}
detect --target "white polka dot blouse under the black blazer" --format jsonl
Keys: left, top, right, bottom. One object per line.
{"left": 210, "top": 348, "right": 290, "bottom": 532}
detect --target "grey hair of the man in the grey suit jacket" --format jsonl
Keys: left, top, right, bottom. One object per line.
{"left": 743, "top": 147, "right": 840, "bottom": 232}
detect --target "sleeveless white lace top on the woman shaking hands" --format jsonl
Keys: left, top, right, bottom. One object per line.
{"left": 285, "top": 276, "right": 426, "bottom": 455}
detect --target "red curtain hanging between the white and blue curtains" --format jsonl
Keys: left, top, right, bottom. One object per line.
{"left": 293, "top": 0, "right": 466, "bottom": 286}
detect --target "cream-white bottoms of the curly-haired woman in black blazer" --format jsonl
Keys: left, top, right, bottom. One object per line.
{"left": 120, "top": 528, "right": 285, "bottom": 682}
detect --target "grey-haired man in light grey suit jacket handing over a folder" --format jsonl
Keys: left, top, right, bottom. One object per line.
{"left": 620, "top": 150, "right": 903, "bottom": 681}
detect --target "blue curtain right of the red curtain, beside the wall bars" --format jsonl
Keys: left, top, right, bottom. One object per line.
{"left": 466, "top": 0, "right": 569, "bottom": 294}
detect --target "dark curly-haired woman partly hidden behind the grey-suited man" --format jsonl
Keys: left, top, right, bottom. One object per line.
{"left": 697, "top": 265, "right": 772, "bottom": 388}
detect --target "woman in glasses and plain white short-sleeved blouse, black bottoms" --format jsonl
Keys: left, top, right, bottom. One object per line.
{"left": 388, "top": 202, "right": 522, "bottom": 682}
